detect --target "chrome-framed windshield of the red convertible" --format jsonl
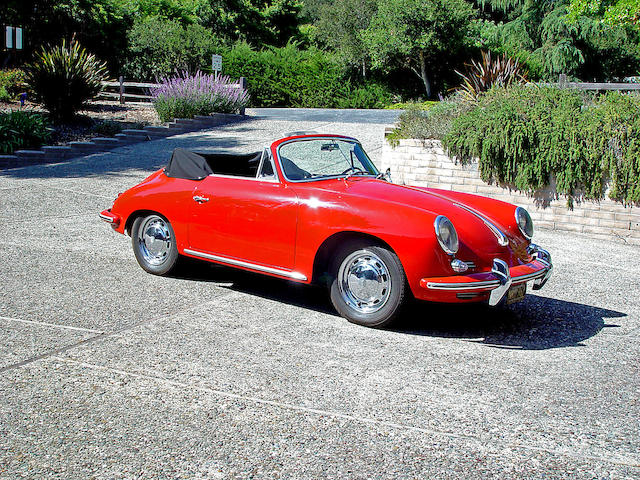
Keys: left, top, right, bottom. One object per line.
{"left": 278, "top": 138, "right": 378, "bottom": 181}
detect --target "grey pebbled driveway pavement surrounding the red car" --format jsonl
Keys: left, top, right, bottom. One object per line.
{"left": 0, "top": 114, "right": 640, "bottom": 479}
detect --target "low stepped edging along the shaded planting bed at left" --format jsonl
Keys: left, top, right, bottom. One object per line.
{"left": 0, "top": 113, "right": 246, "bottom": 170}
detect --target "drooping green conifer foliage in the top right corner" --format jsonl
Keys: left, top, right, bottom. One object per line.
{"left": 478, "top": 0, "right": 640, "bottom": 80}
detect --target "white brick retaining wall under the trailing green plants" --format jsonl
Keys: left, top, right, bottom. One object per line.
{"left": 380, "top": 140, "right": 640, "bottom": 245}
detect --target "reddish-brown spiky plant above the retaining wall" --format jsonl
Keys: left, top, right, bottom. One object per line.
{"left": 456, "top": 51, "right": 527, "bottom": 101}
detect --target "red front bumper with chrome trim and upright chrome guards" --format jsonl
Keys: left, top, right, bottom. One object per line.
{"left": 420, "top": 243, "right": 553, "bottom": 305}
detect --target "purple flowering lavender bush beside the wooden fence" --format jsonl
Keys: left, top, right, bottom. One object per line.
{"left": 151, "top": 71, "right": 249, "bottom": 122}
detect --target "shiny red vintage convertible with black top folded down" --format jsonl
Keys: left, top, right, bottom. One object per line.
{"left": 100, "top": 133, "right": 553, "bottom": 326}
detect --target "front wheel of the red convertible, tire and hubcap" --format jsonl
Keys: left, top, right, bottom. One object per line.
{"left": 329, "top": 241, "right": 407, "bottom": 327}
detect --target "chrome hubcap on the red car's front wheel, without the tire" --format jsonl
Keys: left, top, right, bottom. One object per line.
{"left": 338, "top": 250, "right": 391, "bottom": 313}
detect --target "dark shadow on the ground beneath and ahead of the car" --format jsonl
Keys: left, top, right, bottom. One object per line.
{"left": 173, "top": 259, "right": 626, "bottom": 350}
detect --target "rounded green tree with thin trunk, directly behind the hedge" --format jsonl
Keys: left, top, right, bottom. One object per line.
{"left": 363, "top": 0, "right": 476, "bottom": 97}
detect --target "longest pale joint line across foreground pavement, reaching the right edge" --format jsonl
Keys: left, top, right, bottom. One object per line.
{"left": 50, "top": 355, "right": 640, "bottom": 468}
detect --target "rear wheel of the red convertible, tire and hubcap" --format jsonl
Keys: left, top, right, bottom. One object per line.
{"left": 131, "top": 214, "right": 178, "bottom": 275}
